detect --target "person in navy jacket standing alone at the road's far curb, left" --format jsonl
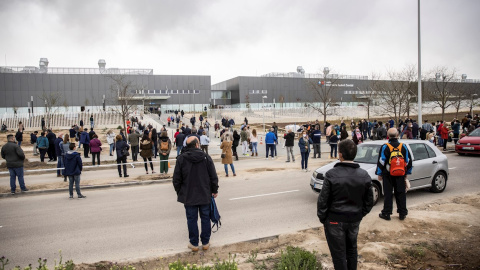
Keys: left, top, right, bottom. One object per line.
{"left": 65, "top": 143, "right": 87, "bottom": 199}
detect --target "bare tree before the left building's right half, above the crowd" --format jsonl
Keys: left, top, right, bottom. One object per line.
{"left": 106, "top": 74, "right": 137, "bottom": 129}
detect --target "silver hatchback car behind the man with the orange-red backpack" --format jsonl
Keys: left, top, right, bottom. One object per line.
{"left": 310, "top": 140, "right": 449, "bottom": 204}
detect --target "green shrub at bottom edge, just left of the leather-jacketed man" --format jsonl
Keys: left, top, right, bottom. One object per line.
{"left": 275, "top": 246, "right": 322, "bottom": 270}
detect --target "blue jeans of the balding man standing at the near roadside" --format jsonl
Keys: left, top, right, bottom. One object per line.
{"left": 185, "top": 204, "right": 212, "bottom": 246}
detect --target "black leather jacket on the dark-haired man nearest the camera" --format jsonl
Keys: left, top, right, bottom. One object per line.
{"left": 317, "top": 162, "right": 373, "bottom": 223}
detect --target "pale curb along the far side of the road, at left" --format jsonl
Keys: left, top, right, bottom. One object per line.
{"left": 0, "top": 178, "right": 173, "bottom": 198}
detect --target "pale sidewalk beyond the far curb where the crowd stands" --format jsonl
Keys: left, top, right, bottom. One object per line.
{"left": 0, "top": 138, "right": 333, "bottom": 197}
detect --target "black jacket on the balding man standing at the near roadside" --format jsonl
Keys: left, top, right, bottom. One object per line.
{"left": 173, "top": 148, "right": 218, "bottom": 206}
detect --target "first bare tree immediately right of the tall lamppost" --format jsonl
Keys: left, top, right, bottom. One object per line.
{"left": 425, "top": 67, "right": 458, "bottom": 120}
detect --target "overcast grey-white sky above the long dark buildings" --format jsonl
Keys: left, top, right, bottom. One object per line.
{"left": 0, "top": 0, "right": 480, "bottom": 83}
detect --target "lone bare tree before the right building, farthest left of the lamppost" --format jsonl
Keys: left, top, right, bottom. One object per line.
{"left": 305, "top": 68, "right": 340, "bottom": 123}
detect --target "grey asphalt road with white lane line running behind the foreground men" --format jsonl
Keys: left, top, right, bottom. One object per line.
{"left": 0, "top": 153, "right": 480, "bottom": 266}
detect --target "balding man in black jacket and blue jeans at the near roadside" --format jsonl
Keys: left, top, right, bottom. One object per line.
{"left": 173, "top": 135, "right": 218, "bottom": 252}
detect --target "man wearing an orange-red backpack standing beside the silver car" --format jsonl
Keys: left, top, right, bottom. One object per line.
{"left": 375, "top": 128, "right": 412, "bottom": 220}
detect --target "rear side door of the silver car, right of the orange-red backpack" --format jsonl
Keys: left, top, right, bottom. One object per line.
{"left": 409, "top": 143, "right": 436, "bottom": 188}
